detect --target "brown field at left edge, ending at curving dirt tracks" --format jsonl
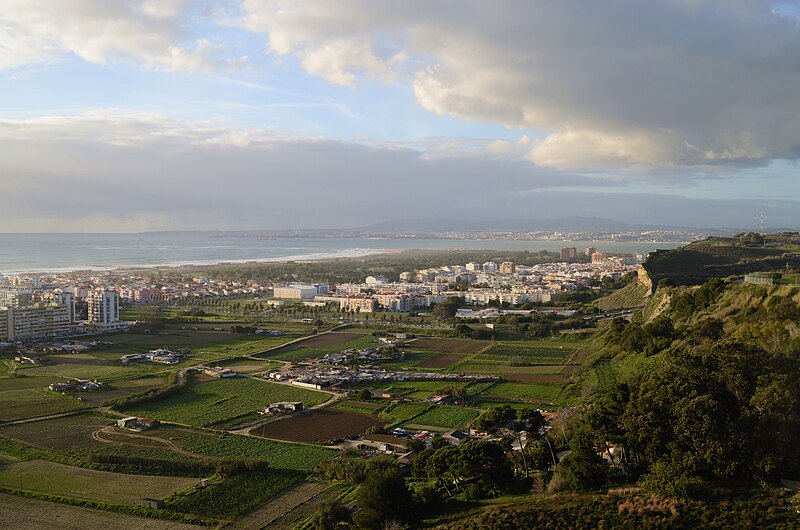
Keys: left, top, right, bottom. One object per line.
{"left": 0, "top": 413, "right": 113, "bottom": 451}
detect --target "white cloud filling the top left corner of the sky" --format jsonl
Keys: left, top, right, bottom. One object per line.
{"left": 0, "top": 0, "right": 243, "bottom": 72}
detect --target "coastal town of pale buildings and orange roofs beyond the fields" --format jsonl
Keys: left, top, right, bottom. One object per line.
{"left": 0, "top": 247, "right": 643, "bottom": 343}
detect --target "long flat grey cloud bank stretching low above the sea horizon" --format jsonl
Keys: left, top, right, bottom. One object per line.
{"left": 0, "top": 109, "right": 613, "bottom": 231}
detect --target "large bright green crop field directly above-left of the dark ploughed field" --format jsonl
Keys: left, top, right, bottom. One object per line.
{"left": 124, "top": 377, "right": 329, "bottom": 426}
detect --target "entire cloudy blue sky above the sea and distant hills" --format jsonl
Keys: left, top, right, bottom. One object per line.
{"left": 0, "top": 0, "right": 800, "bottom": 232}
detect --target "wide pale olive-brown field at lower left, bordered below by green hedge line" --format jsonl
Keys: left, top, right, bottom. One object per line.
{"left": 0, "top": 460, "right": 197, "bottom": 504}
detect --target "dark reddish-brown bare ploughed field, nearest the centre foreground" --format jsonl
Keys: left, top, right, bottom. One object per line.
{"left": 252, "top": 409, "right": 386, "bottom": 442}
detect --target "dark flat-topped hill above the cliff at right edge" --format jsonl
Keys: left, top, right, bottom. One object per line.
{"left": 642, "top": 232, "right": 800, "bottom": 286}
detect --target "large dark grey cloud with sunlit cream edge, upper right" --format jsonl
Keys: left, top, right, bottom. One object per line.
{"left": 242, "top": 0, "right": 800, "bottom": 172}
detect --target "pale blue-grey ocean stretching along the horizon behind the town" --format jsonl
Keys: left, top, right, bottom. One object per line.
{"left": 0, "top": 232, "right": 678, "bottom": 274}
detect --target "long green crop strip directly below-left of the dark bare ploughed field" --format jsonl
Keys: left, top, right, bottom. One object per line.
{"left": 142, "top": 425, "right": 336, "bottom": 471}
